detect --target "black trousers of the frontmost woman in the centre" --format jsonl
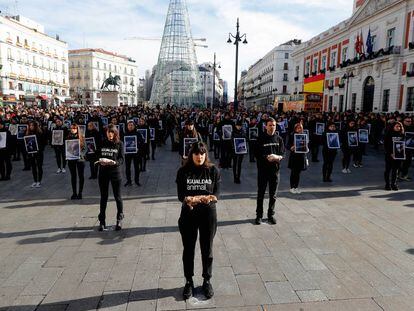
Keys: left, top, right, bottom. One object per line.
{"left": 178, "top": 204, "right": 217, "bottom": 280}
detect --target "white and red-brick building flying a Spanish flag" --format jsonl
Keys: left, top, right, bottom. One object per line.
{"left": 291, "top": 0, "right": 414, "bottom": 112}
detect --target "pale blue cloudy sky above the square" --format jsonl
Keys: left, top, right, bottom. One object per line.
{"left": 0, "top": 0, "right": 353, "bottom": 98}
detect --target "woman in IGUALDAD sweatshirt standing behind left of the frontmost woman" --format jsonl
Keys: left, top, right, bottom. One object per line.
{"left": 98, "top": 125, "right": 124, "bottom": 231}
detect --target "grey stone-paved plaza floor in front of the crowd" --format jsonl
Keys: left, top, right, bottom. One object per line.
{"left": 0, "top": 146, "right": 414, "bottom": 311}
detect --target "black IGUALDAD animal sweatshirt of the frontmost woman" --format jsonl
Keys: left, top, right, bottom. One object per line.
{"left": 176, "top": 165, "right": 221, "bottom": 204}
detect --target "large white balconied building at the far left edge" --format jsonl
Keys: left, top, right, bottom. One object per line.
{"left": 0, "top": 16, "right": 69, "bottom": 105}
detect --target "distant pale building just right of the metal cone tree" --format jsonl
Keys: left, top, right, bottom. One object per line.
{"left": 198, "top": 63, "right": 224, "bottom": 107}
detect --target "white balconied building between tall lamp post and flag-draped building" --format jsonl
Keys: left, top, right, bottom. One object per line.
{"left": 238, "top": 40, "right": 300, "bottom": 107}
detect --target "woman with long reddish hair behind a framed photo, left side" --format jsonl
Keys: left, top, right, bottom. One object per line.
{"left": 66, "top": 123, "right": 87, "bottom": 200}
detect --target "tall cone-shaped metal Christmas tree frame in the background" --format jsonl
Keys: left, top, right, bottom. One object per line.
{"left": 150, "top": 0, "right": 202, "bottom": 107}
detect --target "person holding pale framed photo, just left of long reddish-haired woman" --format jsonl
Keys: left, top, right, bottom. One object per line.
{"left": 50, "top": 117, "right": 68, "bottom": 174}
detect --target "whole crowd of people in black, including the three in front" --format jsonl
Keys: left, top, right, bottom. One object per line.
{"left": 0, "top": 105, "right": 414, "bottom": 299}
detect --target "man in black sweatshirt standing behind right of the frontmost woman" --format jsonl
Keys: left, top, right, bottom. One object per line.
{"left": 255, "top": 118, "right": 285, "bottom": 225}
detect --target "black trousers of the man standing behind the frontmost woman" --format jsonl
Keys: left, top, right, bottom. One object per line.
{"left": 256, "top": 168, "right": 279, "bottom": 218}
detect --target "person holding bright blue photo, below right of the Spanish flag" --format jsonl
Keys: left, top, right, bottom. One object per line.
{"left": 322, "top": 122, "right": 340, "bottom": 182}
